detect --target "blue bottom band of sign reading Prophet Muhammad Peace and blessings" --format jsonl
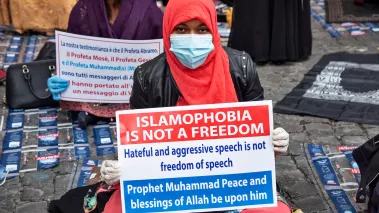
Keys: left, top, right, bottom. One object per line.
{"left": 124, "top": 171, "right": 273, "bottom": 213}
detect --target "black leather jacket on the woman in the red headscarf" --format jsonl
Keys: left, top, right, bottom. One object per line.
{"left": 130, "top": 48, "right": 263, "bottom": 109}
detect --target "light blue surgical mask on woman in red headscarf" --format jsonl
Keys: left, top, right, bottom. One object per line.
{"left": 170, "top": 34, "right": 214, "bottom": 69}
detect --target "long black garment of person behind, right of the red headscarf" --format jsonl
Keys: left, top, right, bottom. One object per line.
{"left": 225, "top": 0, "right": 312, "bottom": 63}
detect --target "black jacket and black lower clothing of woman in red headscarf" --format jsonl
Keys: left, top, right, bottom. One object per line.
{"left": 49, "top": 48, "right": 263, "bottom": 213}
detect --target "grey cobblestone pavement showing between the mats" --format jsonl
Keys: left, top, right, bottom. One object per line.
{"left": 0, "top": 17, "right": 379, "bottom": 213}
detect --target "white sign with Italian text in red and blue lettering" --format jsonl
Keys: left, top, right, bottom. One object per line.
{"left": 56, "top": 31, "right": 163, "bottom": 103}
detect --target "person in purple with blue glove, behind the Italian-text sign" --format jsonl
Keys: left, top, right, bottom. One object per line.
{"left": 48, "top": 0, "right": 163, "bottom": 128}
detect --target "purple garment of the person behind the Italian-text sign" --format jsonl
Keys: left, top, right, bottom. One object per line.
{"left": 67, "top": 0, "right": 163, "bottom": 40}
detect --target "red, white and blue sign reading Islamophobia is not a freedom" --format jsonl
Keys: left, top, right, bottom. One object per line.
{"left": 116, "top": 101, "right": 277, "bottom": 213}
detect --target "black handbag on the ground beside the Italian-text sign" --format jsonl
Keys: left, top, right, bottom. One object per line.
{"left": 6, "top": 59, "right": 59, "bottom": 109}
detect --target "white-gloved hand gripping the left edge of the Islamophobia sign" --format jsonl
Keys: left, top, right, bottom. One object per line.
{"left": 100, "top": 160, "right": 121, "bottom": 185}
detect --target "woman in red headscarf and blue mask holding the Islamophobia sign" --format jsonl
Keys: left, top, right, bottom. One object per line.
{"left": 101, "top": 0, "right": 291, "bottom": 213}
